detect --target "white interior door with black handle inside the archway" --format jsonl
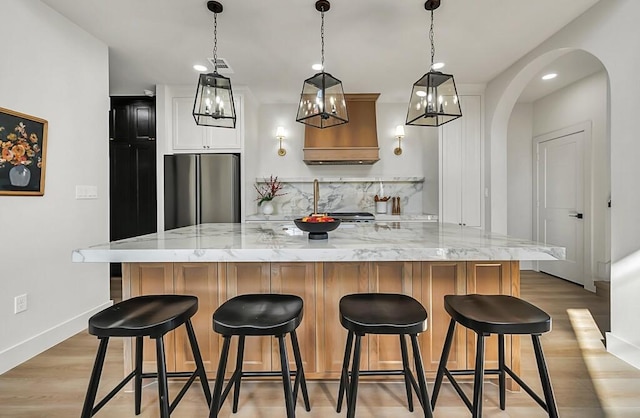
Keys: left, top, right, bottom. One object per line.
{"left": 537, "top": 131, "right": 585, "bottom": 285}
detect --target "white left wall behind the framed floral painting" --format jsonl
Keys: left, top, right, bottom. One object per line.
{"left": 0, "top": 0, "right": 109, "bottom": 373}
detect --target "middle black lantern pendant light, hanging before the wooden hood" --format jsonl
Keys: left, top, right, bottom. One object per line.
{"left": 296, "top": 0, "right": 349, "bottom": 129}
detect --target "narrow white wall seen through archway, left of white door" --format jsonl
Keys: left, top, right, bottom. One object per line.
{"left": 507, "top": 103, "right": 534, "bottom": 270}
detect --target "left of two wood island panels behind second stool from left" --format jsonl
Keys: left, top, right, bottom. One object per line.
{"left": 225, "top": 263, "right": 273, "bottom": 373}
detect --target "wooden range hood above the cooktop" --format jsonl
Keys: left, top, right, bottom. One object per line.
{"left": 303, "top": 93, "right": 380, "bottom": 165}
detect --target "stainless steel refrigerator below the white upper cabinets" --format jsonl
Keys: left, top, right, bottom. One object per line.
{"left": 164, "top": 154, "right": 240, "bottom": 230}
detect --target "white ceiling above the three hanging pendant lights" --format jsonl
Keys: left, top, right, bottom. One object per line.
{"left": 42, "top": 0, "right": 598, "bottom": 103}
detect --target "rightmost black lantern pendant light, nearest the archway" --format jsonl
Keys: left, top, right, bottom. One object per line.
{"left": 407, "top": 0, "right": 462, "bottom": 126}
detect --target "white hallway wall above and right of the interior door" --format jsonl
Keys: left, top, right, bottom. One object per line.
{"left": 533, "top": 71, "right": 611, "bottom": 282}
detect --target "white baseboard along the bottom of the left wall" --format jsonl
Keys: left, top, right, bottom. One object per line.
{"left": 0, "top": 301, "right": 113, "bottom": 374}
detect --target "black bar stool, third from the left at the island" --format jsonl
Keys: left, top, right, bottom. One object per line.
{"left": 336, "top": 293, "right": 433, "bottom": 418}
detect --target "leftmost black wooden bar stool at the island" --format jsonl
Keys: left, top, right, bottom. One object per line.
{"left": 81, "top": 295, "right": 211, "bottom": 418}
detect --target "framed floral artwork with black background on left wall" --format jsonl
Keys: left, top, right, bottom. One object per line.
{"left": 0, "top": 107, "right": 48, "bottom": 196}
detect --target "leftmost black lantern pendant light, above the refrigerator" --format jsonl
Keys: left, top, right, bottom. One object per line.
{"left": 193, "top": 1, "right": 236, "bottom": 128}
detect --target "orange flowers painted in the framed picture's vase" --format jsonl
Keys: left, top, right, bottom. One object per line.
{"left": 0, "top": 122, "right": 42, "bottom": 168}
